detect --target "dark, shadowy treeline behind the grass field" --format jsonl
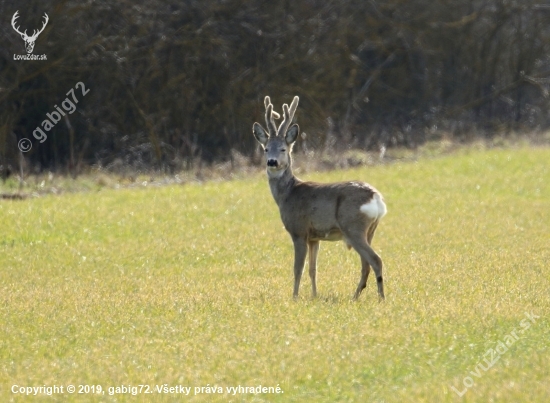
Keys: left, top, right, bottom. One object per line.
{"left": 0, "top": 0, "right": 550, "bottom": 171}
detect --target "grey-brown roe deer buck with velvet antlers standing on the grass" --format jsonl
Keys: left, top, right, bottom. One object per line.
{"left": 252, "top": 97, "right": 386, "bottom": 301}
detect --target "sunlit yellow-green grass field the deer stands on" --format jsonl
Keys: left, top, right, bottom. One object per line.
{"left": 0, "top": 148, "right": 550, "bottom": 402}
